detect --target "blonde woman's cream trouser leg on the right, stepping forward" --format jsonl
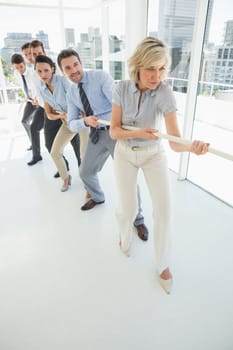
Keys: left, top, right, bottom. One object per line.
{"left": 142, "top": 145, "right": 172, "bottom": 273}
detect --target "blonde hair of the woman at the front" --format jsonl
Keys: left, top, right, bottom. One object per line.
{"left": 128, "top": 36, "right": 170, "bottom": 83}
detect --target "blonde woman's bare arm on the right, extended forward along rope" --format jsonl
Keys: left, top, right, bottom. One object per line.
{"left": 165, "top": 112, "right": 209, "bottom": 155}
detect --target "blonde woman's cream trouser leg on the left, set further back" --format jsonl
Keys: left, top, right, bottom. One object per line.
{"left": 114, "top": 142, "right": 138, "bottom": 251}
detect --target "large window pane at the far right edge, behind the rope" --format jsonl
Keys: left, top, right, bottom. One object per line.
{"left": 188, "top": 0, "right": 233, "bottom": 205}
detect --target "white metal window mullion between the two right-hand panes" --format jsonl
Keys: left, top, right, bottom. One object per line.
{"left": 178, "top": 0, "right": 209, "bottom": 180}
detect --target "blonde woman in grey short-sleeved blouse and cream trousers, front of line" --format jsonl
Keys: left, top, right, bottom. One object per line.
{"left": 110, "top": 37, "right": 208, "bottom": 294}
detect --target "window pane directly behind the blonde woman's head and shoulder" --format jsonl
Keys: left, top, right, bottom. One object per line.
{"left": 148, "top": 0, "right": 197, "bottom": 172}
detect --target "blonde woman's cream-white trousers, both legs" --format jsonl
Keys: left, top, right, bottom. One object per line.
{"left": 114, "top": 141, "right": 171, "bottom": 273}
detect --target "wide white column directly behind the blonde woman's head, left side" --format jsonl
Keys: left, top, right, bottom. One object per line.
{"left": 125, "top": 0, "right": 148, "bottom": 78}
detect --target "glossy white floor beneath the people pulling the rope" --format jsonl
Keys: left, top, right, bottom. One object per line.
{"left": 0, "top": 132, "right": 233, "bottom": 350}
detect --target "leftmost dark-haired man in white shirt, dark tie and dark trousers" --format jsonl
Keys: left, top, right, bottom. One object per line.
{"left": 11, "top": 53, "right": 44, "bottom": 165}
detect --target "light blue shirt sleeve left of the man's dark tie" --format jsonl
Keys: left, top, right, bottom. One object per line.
{"left": 66, "top": 85, "right": 89, "bottom": 132}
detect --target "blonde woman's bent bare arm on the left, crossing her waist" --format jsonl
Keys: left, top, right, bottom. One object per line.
{"left": 110, "top": 104, "right": 158, "bottom": 140}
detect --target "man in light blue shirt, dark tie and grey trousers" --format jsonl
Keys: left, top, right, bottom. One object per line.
{"left": 57, "top": 49, "right": 148, "bottom": 240}
